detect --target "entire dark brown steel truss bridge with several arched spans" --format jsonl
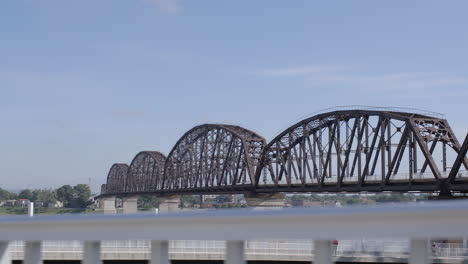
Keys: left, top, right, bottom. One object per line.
{"left": 101, "top": 109, "right": 468, "bottom": 196}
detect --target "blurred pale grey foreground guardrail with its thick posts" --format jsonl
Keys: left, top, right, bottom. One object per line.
{"left": 0, "top": 201, "right": 468, "bottom": 264}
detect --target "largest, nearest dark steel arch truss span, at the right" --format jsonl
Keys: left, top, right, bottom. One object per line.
{"left": 255, "top": 110, "right": 468, "bottom": 192}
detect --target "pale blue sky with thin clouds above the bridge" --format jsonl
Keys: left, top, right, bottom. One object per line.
{"left": 0, "top": 0, "right": 468, "bottom": 193}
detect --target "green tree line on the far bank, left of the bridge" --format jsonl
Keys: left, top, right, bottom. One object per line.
{"left": 0, "top": 184, "right": 91, "bottom": 208}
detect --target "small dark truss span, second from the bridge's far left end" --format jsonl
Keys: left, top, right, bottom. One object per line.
{"left": 125, "top": 151, "right": 166, "bottom": 193}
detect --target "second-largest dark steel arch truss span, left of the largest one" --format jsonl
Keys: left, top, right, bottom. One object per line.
{"left": 164, "top": 124, "right": 266, "bottom": 190}
